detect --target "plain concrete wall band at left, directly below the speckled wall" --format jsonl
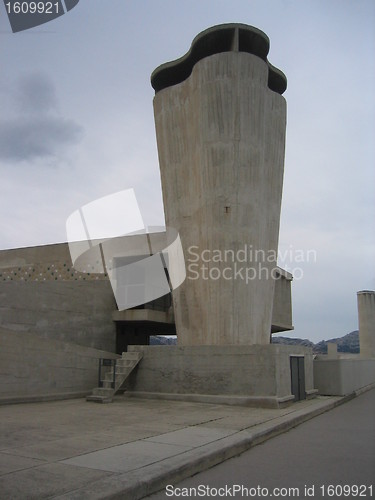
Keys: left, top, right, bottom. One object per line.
{"left": 0, "top": 281, "right": 116, "bottom": 352}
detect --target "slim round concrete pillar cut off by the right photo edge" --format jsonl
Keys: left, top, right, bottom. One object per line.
{"left": 357, "top": 290, "right": 375, "bottom": 359}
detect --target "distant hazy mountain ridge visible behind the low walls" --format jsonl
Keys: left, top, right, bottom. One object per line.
{"left": 150, "top": 330, "right": 359, "bottom": 354}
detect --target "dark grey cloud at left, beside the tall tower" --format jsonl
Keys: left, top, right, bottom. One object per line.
{"left": 0, "top": 73, "right": 83, "bottom": 162}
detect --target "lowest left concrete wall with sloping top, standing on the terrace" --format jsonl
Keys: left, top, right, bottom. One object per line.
{"left": 0, "top": 329, "right": 117, "bottom": 403}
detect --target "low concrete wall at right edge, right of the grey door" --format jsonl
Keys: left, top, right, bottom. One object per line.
{"left": 314, "top": 355, "right": 375, "bottom": 396}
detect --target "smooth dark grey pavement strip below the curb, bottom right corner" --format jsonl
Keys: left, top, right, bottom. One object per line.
{"left": 148, "top": 390, "right": 375, "bottom": 500}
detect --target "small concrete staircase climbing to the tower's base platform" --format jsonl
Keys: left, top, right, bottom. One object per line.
{"left": 86, "top": 352, "right": 142, "bottom": 403}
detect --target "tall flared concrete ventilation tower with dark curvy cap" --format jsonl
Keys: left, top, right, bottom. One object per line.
{"left": 151, "top": 24, "right": 286, "bottom": 346}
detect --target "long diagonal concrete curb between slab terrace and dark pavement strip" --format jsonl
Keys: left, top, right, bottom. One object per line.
{"left": 53, "top": 394, "right": 362, "bottom": 500}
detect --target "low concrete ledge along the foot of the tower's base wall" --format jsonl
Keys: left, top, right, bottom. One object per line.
{"left": 124, "top": 391, "right": 294, "bottom": 408}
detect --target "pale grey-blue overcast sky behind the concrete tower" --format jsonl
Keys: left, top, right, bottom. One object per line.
{"left": 0, "top": 0, "right": 375, "bottom": 341}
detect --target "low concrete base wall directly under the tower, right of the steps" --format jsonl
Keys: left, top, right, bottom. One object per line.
{"left": 127, "top": 344, "right": 314, "bottom": 406}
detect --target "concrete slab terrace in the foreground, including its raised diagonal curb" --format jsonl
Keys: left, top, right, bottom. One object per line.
{"left": 0, "top": 396, "right": 356, "bottom": 500}
